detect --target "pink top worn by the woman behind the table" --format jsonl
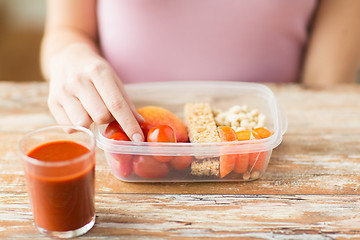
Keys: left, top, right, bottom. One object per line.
{"left": 97, "top": 0, "right": 317, "bottom": 82}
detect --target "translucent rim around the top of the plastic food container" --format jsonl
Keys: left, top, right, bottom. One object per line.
{"left": 93, "top": 81, "right": 287, "bottom": 156}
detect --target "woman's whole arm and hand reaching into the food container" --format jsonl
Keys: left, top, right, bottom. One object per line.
{"left": 41, "top": 0, "right": 144, "bottom": 141}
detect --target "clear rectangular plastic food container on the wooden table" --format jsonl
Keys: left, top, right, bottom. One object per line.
{"left": 94, "top": 81, "right": 287, "bottom": 182}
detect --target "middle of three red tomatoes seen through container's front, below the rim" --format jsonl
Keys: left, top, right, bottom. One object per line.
{"left": 133, "top": 155, "right": 170, "bottom": 179}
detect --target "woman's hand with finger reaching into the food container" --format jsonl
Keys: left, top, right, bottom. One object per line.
{"left": 48, "top": 43, "right": 144, "bottom": 141}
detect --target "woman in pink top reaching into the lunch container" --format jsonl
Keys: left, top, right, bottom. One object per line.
{"left": 41, "top": 0, "right": 360, "bottom": 141}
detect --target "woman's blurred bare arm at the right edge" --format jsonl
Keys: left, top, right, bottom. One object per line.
{"left": 302, "top": 0, "right": 360, "bottom": 88}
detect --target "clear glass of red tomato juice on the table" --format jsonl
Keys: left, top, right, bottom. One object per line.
{"left": 19, "top": 126, "right": 96, "bottom": 238}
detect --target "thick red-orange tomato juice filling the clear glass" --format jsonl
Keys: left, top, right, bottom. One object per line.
{"left": 25, "top": 140, "right": 95, "bottom": 231}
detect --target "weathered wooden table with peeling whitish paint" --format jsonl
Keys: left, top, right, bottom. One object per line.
{"left": 0, "top": 82, "right": 360, "bottom": 239}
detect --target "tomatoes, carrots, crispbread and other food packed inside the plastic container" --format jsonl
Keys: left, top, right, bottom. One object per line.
{"left": 104, "top": 102, "right": 272, "bottom": 180}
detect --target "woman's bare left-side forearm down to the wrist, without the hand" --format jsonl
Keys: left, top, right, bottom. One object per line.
{"left": 41, "top": 0, "right": 98, "bottom": 79}
